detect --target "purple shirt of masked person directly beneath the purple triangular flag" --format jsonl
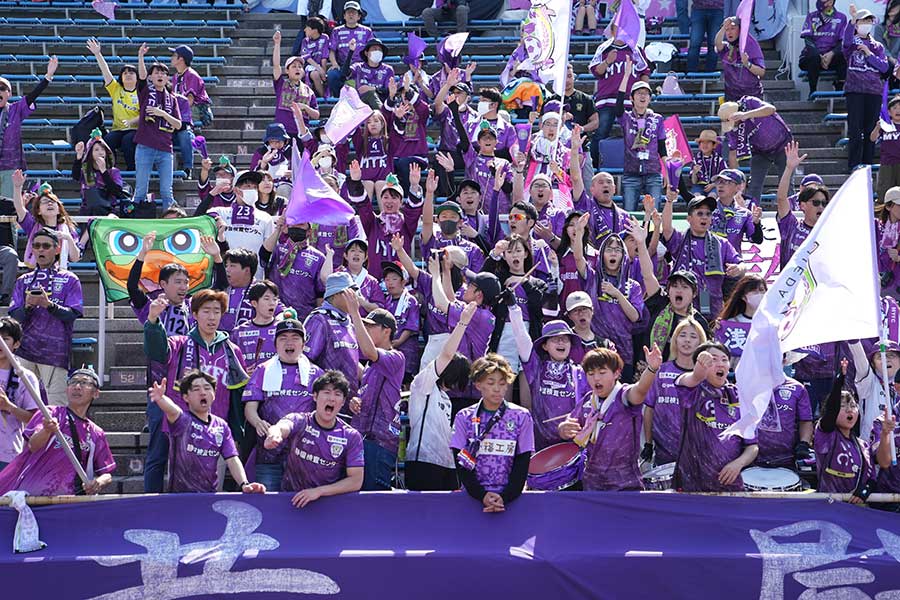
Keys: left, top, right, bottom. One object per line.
{"left": 268, "top": 240, "right": 325, "bottom": 321}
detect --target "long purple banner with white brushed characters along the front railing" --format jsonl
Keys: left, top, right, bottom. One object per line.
{"left": 0, "top": 492, "right": 900, "bottom": 600}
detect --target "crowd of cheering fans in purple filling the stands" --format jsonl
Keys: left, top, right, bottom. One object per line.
{"left": 0, "top": 0, "right": 900, "bottom": 512}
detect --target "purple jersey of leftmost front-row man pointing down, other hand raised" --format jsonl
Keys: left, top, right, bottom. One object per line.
{"left": 169, "top": 410, "right": 238, "bottom": 493}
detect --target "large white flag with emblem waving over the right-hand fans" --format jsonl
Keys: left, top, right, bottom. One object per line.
{"left": 722, "top": 167, "right": 881, "bottom": 438}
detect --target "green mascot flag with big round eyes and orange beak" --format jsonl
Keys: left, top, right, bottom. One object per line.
{"left": 90, "top": 215, "right": 216, "bottom": 302}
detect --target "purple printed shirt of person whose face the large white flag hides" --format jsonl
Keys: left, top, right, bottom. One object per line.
{"left": 756, "top": 377, "right": 812, "bottom": 470}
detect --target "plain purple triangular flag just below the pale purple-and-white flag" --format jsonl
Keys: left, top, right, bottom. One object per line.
{"left": 284, "top": 148, "right": 355, "bottom": 225}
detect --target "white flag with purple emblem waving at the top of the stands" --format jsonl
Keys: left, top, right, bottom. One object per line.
{"left": 522, "top": 0, "right": 572, "bottom": 98}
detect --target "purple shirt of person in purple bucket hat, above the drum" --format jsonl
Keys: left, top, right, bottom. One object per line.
{"left": 522, "top": 356, "right": 588, "bottom": 450}
